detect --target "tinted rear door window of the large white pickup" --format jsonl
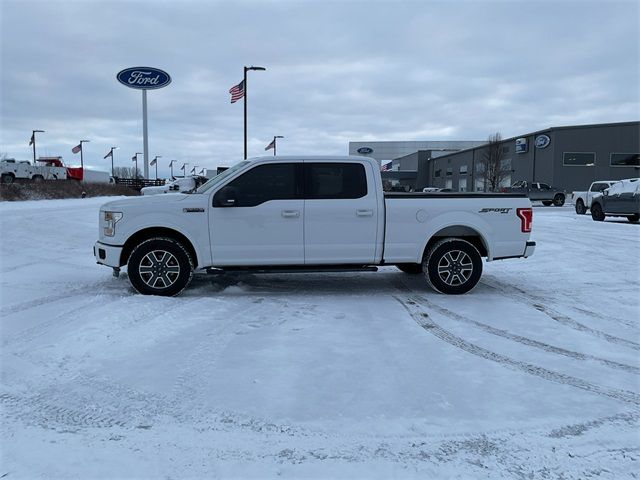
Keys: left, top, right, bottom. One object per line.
{"left": 304, "top": 163, "right": 367, "bottom": 200}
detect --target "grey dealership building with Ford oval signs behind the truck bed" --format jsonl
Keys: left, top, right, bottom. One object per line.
{"left": 349, "top": 122, "right": 640, "bottom": 192}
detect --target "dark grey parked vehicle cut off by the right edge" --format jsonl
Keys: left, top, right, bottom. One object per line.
{"left": 591, "top": 178, "right": 640, "bottom": 222}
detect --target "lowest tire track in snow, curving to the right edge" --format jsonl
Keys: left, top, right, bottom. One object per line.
{"left": 393, "top": 295, "right": 640, "bottom": 405}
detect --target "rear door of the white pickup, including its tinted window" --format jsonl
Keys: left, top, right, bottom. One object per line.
{"left": 304, "top": 161, "right": 378, "bottom": 265}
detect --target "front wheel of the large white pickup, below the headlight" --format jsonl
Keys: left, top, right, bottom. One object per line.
{"left": 127, "top": 237, "right": 193, "bottom": 297}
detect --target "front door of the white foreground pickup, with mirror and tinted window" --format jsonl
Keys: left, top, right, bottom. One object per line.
{"left": 209, "top": 162, "right": 304, "bottom": 266}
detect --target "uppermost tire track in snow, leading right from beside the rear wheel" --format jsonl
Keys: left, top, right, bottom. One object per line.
{"left": 481, "top": 280, "right": 640, "bottom": 340}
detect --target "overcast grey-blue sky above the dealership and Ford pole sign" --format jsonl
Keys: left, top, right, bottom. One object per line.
{"left": 0, "top": 0, "right": 640, "bottom": 176}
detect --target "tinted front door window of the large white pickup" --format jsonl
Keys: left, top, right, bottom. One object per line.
{"left": 225, "top": 163, "right": 302, "bottom": 207}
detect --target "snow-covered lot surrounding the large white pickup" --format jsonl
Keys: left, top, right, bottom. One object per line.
{"left": 0, "top": 198, "right": 640, "bottom": 479}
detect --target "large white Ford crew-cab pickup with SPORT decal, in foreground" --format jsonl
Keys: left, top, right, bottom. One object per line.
{"left": 94, "top": 156, "right": 535, "bottom": 296}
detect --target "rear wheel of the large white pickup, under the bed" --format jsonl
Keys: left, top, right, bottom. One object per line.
{"left": 422, "top": 238, "right": 482, "bottom": 295}
